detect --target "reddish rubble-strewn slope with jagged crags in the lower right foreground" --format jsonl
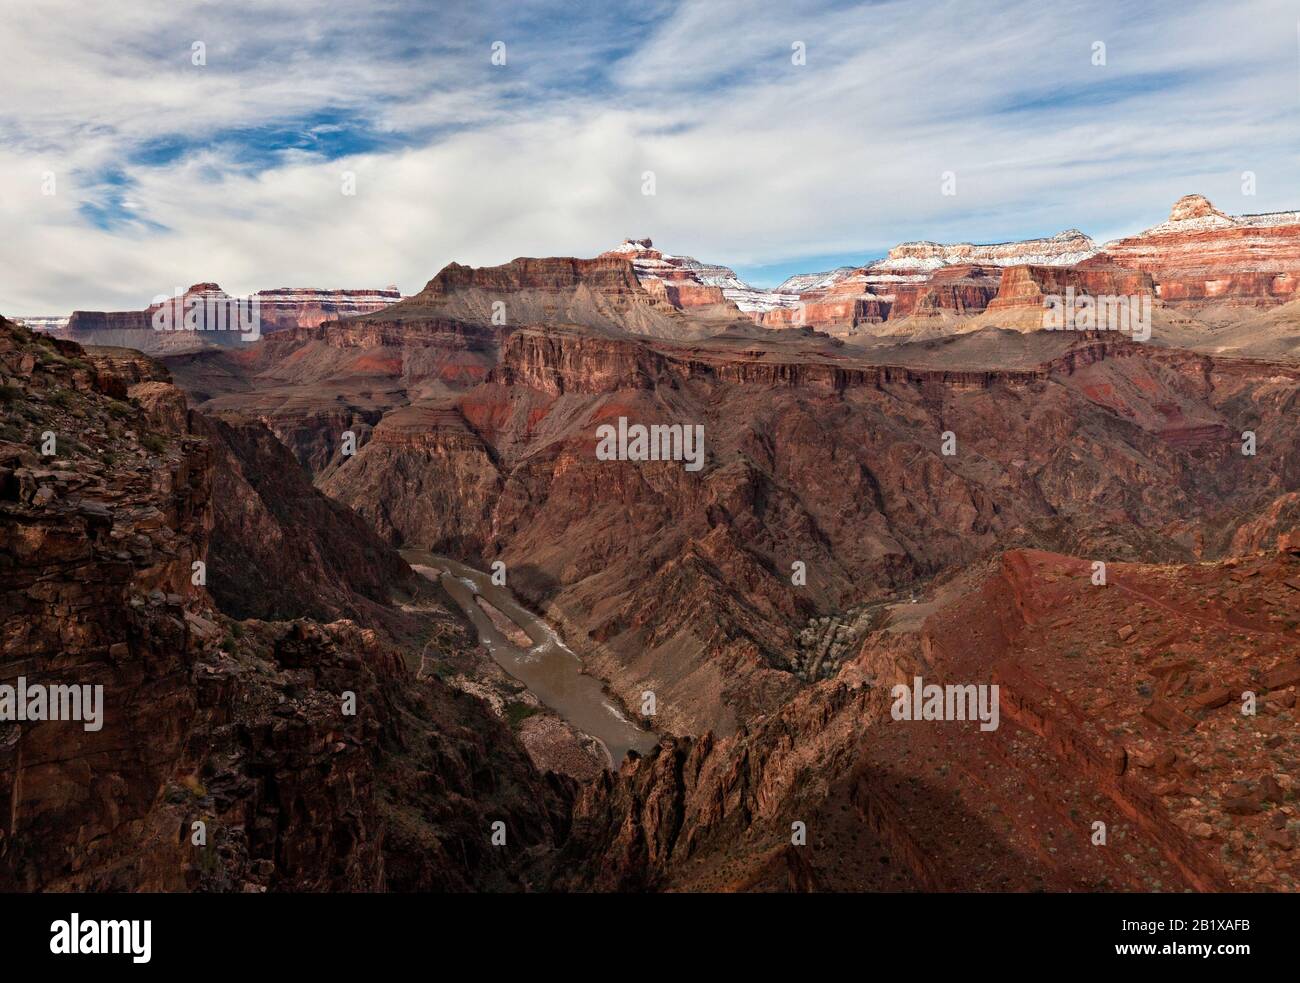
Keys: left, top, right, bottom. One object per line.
{"left": 555, "top": 550, "right": 1300, "bottom": 892}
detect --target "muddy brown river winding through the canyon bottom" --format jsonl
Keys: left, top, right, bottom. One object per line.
{"left": 402, "top": 549, "right": 659, "bottom": 766}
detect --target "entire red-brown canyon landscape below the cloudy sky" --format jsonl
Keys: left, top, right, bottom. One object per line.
{"left": 0, "top": 189, "right": 1300, "bottom": 892}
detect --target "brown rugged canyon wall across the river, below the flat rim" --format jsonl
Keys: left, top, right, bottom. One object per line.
{"left": 322, "top": 322, "right": 1297, "bottom": 733}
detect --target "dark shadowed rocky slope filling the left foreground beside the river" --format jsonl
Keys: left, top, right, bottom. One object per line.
{"left": 0, "top": 322, "right": 571, "bottom": 891}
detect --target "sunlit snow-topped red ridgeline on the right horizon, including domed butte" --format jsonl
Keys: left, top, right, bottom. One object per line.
{"left": 754, "top": 195, "right": 1300, "bottom": 334}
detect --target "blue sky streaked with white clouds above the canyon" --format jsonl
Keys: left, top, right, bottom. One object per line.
{"left": 0, "top": 0, "right": 1300, "bottom": 316}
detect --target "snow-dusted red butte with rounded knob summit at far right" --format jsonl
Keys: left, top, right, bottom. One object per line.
{"left": 1104, "top": 195, "right": 1300, "bottom": 307}
